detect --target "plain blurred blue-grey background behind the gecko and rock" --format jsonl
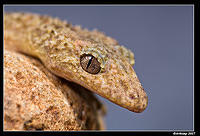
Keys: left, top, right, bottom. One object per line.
{"left": 4, "top": 5, "right": 194, "bottom": 131}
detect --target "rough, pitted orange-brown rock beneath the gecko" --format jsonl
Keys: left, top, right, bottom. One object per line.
{"left": 4, "top": 50, "right": 105, "bottom": 130}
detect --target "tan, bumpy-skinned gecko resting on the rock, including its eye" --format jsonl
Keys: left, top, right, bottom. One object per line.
{"left": 4, "top": 13, "right": 148, "bottom": 113}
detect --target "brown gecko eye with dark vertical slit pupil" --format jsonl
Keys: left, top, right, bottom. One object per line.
{"left": 80, "top": 54, "right": 101, "bottom": 74}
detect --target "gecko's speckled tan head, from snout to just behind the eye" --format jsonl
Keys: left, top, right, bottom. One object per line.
{"left": 55, "top": 40, "right": 148, "bottom": 113}
